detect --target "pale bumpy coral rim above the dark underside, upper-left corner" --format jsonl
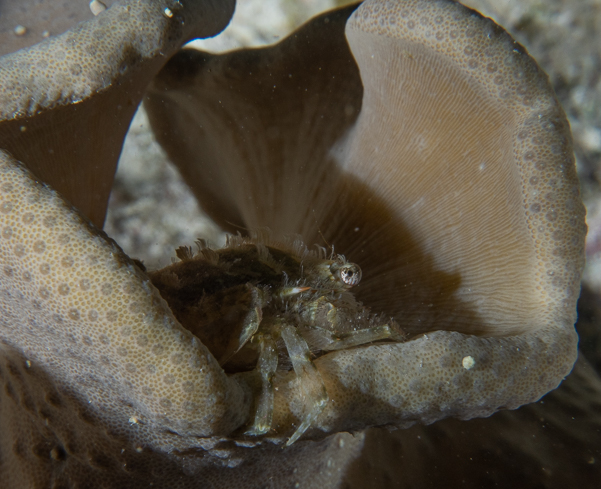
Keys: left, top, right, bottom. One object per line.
{"left": 0, "top": 0, "right": 230, "bottom": 119}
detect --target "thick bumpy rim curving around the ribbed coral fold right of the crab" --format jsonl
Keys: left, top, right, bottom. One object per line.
{"left": 282, "top": 1, "right": 586, "bottom": 429}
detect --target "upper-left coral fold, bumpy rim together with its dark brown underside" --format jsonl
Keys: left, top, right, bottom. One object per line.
{"left": 0, "top": 0, "right": 234, "bottom": 227}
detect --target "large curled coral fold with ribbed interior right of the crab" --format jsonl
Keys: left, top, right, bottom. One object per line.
{"left": 146, "top": 1, "right": 586, "bottom": 431}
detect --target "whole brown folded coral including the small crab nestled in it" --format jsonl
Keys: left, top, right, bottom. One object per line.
{"left": 0, "top": 0, "right": 601, "bottom": 489}
